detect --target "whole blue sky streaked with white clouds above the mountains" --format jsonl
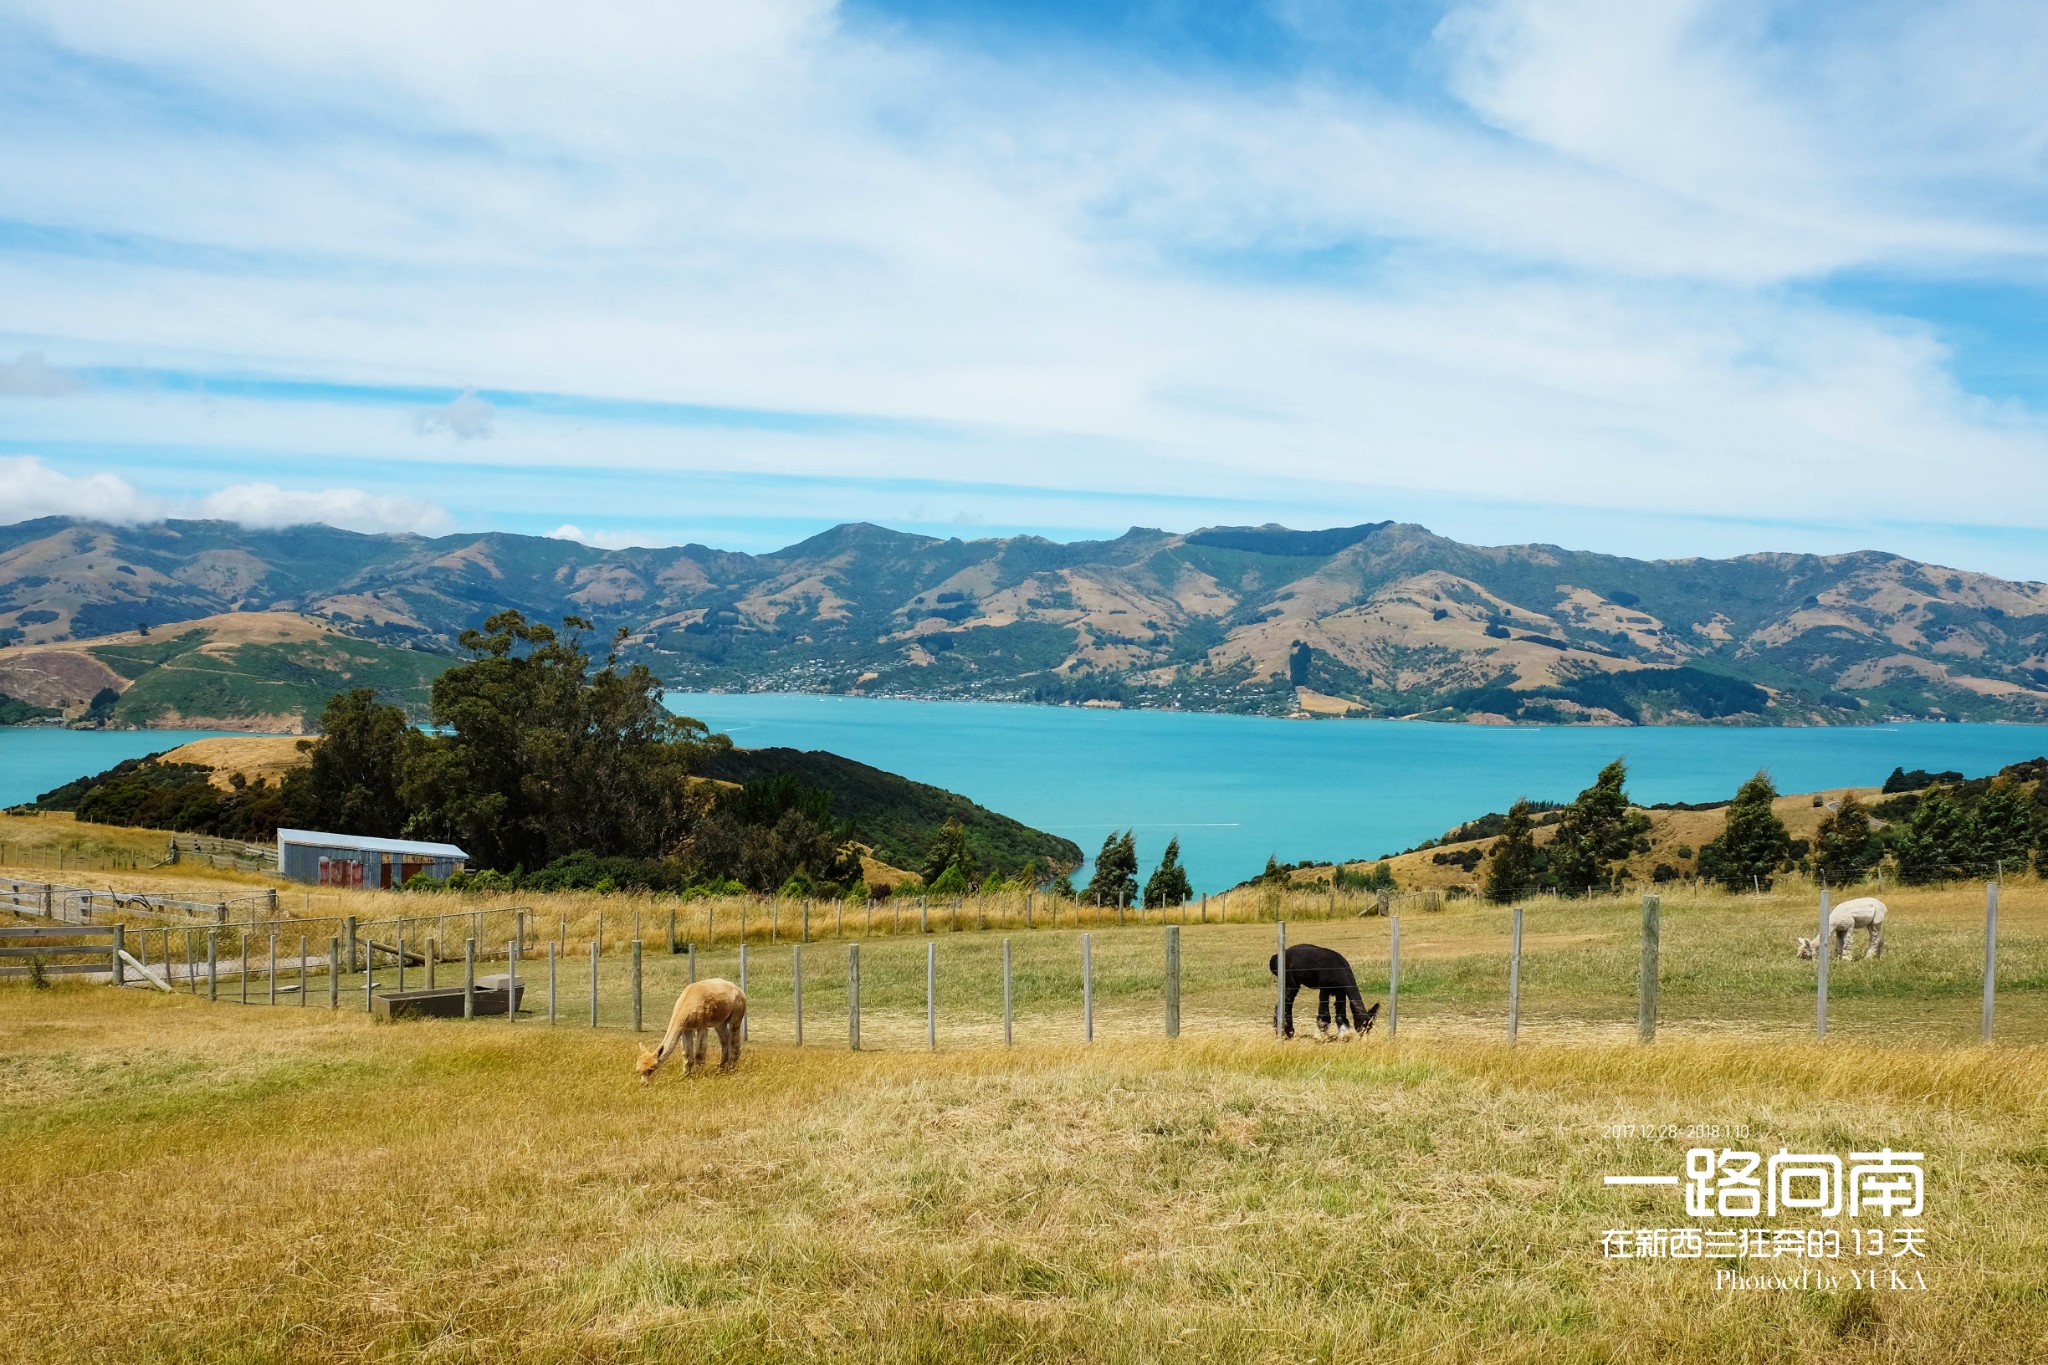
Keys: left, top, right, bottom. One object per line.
{"left": 0, "top": 0, "right": 2048, "bottom": 579}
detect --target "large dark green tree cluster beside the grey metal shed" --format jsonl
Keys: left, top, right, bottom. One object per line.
{"left": 305, "top": 612, "right": 860, "bottom": 894}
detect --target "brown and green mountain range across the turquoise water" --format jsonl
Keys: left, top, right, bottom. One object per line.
{"left": 0, "top": 518, "right": 2048, "bottom": 724}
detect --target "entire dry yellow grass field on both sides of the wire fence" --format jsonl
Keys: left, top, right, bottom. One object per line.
{"left": 0, "top": 874, "right": 2048, "bottom": 1363}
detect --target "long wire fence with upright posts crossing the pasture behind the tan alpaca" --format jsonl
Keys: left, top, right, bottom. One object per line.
{"left": 44, "top": 884, "right": 2048, "bottom": 1050}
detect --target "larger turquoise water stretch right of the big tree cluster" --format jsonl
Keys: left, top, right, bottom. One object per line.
{"left": 668, "top": 694, "right": 2048, "bottom": 890}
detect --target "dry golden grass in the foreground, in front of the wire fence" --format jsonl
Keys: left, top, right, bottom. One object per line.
{"left": 0, "top": 986, "right": 2048, "bottom": 1361}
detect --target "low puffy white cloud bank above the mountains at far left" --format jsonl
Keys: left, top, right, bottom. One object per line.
{"left": 0, "top": 454, "right": 455, "bottom": 534}
